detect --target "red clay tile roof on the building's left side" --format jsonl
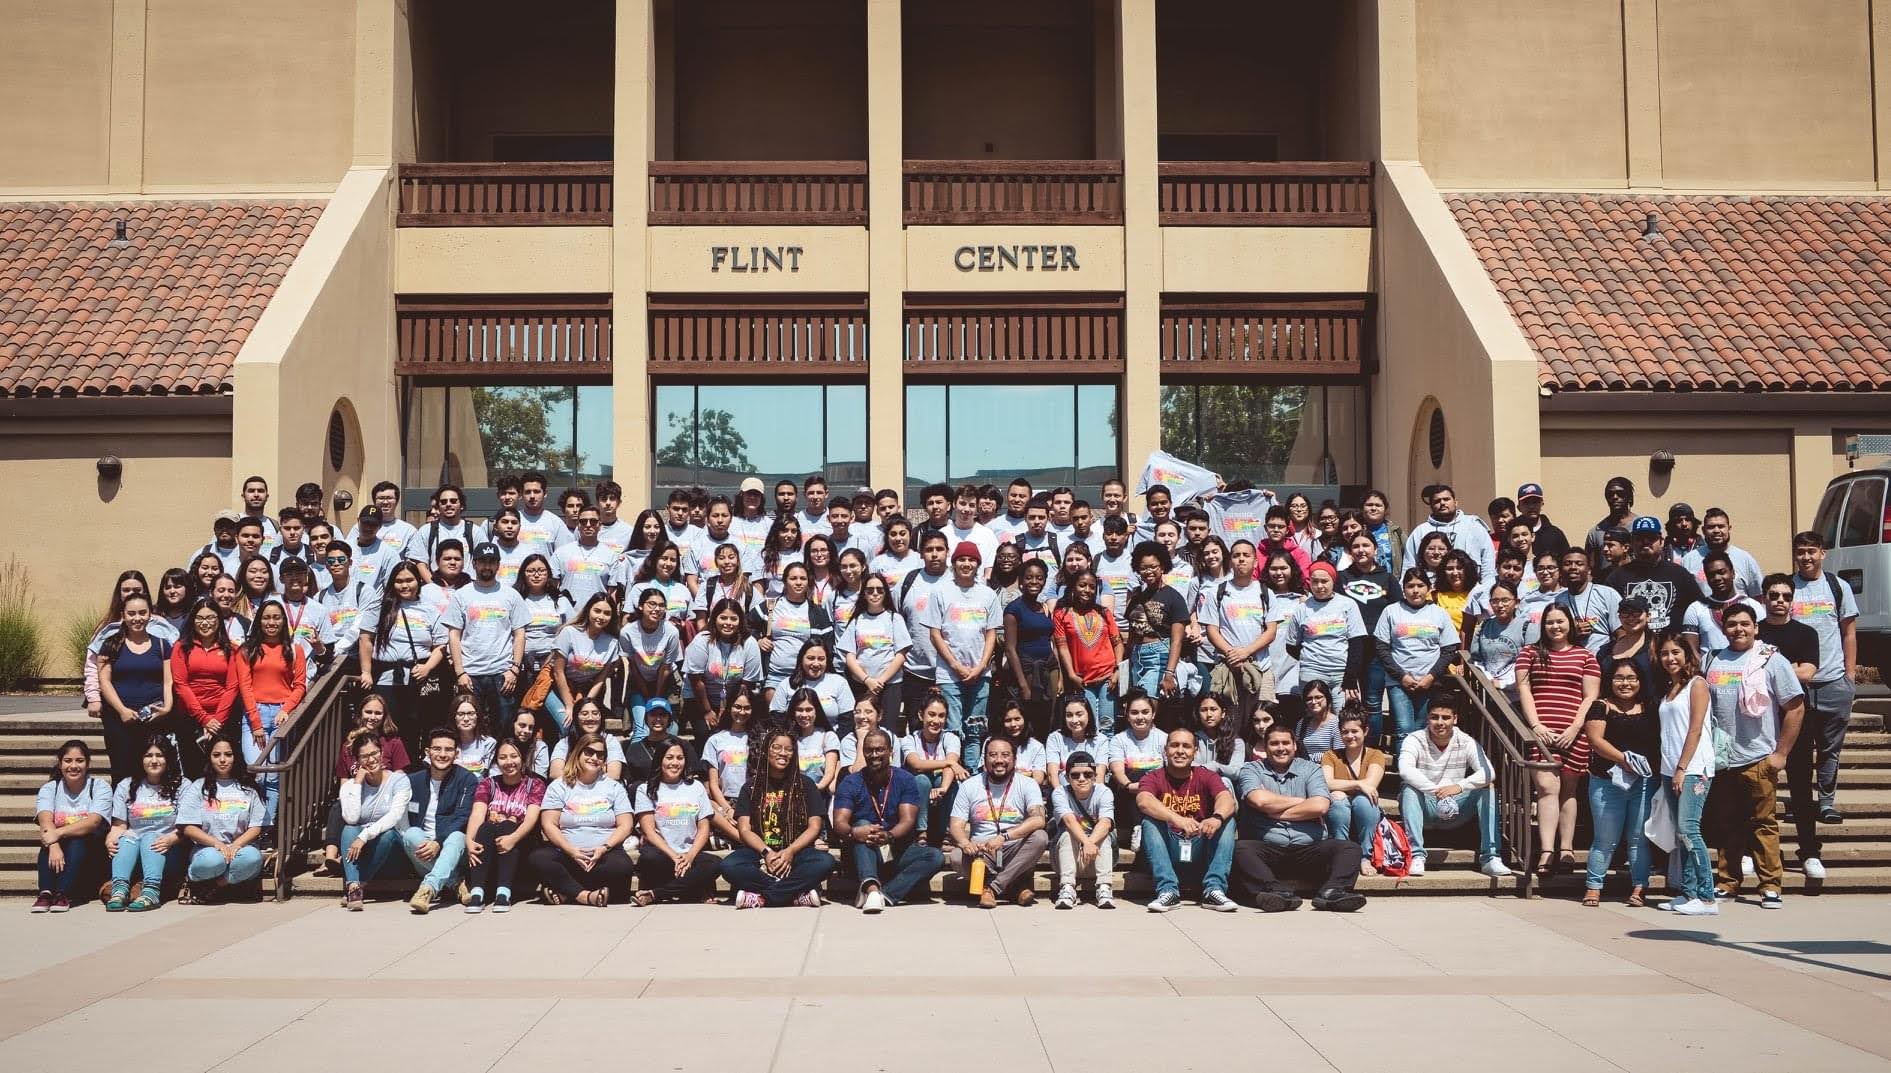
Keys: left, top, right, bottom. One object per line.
{"left": 0, "top": 201, "right": 321, "bottom": 397}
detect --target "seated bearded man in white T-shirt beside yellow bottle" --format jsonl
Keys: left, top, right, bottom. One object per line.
{"left": 946, "top": 738, "right": 1050, "bottom": 908}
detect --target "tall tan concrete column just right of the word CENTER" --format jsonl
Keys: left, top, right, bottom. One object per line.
{"left": 1116, "top": 0, "right": 1163, "bottom": 503}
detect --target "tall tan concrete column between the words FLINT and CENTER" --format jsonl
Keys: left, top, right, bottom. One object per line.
{"left": 866, "top": 0, "right": 906, "bottom": 496}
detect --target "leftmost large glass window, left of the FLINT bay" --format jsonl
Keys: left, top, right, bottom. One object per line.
{"left": 403, "top": 384, "right": 611, "bottom": 517}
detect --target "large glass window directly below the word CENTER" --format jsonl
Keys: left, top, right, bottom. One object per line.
{"left": 906, "top": 384, "right": 1118, "bottom": 503}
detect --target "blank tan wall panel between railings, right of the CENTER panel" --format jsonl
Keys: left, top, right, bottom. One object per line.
{"left": 1161, "top": 227, "right": 1373, "bottom": 293}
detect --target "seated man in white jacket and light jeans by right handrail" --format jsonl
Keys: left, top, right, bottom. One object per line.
{"left": 1399, "top": 691, "right": 1511, "bottom": 878}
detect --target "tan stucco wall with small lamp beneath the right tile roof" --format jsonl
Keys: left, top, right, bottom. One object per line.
{"left": 1543, "top": 414, "right": 1792, "bottom": 572}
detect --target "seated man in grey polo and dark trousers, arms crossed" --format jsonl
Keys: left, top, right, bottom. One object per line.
{"left": 1235, "top": 723, "right": 1365, "bottom": 912}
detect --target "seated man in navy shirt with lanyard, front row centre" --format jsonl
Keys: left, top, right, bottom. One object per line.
{"left": 834, "top": 727, "right": 946, "bottom": 912}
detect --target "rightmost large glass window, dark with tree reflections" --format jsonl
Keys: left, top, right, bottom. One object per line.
{"left": 1161, "top": 384, "right": 1367, "bottom": 501}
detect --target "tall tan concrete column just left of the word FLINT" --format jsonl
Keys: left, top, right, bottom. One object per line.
{"left": 611, "top": 0, "right": 656, "bottom": 501}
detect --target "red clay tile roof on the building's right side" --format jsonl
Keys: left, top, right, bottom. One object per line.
{"left": 1447, "top": 193, "right": 1891, "bottom": 392}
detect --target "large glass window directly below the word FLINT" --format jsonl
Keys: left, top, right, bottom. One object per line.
{"left": 652, "top": 384, "right": 866, "bottom": 501}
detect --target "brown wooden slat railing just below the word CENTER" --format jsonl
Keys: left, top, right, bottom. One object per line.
{"left": 904, "top": 293, "right": 1123, "bottom": 375}
